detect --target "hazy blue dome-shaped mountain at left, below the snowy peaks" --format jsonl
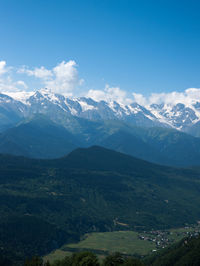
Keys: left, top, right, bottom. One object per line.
{"left": 0, "top": 115, "right": 79, "bottom": 158}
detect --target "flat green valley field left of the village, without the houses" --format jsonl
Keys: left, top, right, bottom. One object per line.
{"left": 44, "top": 231, "right": 156, "bottom": 262}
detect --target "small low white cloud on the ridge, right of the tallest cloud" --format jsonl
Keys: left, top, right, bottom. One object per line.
{"left": 86, "top": 85, "right": 132, "bottom": 104}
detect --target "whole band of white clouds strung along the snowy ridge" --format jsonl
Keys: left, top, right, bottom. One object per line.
{"left": 0, "top": 60, "right": 200, "bottom": 106}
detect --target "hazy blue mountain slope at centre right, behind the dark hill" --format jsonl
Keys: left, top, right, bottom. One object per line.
{"left": 76, "top": 121, "right": 200, "bottom": 166}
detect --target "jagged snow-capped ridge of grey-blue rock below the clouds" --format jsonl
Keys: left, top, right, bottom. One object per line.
{"left": 0, "top": 89, "right": 200, "bottom": 135}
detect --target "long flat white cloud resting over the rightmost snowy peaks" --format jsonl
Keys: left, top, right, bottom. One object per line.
{"left": 132, "top": 88, "right": 200, "bottom": 106}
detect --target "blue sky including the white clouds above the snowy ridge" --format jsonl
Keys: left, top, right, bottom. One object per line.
{"left": 0, "top": 0, "right": 200, "bottom": 103}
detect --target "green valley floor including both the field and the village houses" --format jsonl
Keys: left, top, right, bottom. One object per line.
{"left": 44, "top": 226, "right": 200, "bottom": 262}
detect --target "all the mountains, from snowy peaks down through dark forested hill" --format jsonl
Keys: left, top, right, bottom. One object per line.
{"left": 0, "top": 89, "right": 200, "bottom": 265}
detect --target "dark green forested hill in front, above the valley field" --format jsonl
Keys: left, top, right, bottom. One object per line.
{"left": 0, "top": 146, "right": 200, "bottom": 260}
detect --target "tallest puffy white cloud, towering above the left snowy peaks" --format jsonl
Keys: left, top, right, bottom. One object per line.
{"left": 18, "top": 60, "right": 83, "bottom": 95}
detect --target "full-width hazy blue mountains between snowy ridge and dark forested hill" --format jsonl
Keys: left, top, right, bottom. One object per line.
{"left": 0, "top": 114, "right": 200, "bottom": 166}
